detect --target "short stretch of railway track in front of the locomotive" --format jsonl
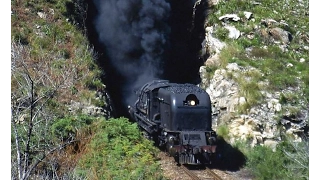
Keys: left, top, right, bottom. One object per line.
{"left": 180, "top": 165, "right": 222, "bottom": 180}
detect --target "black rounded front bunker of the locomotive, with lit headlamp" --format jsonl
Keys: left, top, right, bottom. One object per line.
{"left": 158, "top": 84, "right": 211, "bottom": 131}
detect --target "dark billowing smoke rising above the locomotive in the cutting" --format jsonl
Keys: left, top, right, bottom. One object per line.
{"left": 94, "top": 0, "right": 170, "bottom": 104}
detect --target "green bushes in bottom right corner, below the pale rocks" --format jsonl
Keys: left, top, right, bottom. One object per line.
{"left": 241, "top": 137, "right": 309, "bottom": 180}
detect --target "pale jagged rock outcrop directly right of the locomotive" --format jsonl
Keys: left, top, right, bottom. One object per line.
{"left": 200, "top": 63, "right": 309, "bottom": 147}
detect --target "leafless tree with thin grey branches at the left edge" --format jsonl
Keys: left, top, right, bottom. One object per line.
{"left": 11, "top": 42, "right": 79, "bottom": 180}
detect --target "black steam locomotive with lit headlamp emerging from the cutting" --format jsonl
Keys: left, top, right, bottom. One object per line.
{"left": 129, "top": 80, "right": 217, "bottom": 165}
